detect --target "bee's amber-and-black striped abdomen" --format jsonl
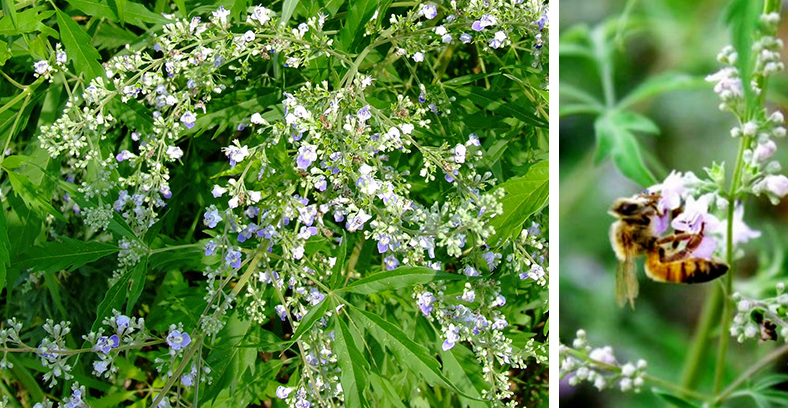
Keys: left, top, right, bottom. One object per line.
{"left": 646, "top": 251, "right": 728, "bottom": 283}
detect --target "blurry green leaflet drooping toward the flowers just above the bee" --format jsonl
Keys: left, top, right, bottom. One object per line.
{"left": 594, "top": 111, "right": 656, "bottom": 187}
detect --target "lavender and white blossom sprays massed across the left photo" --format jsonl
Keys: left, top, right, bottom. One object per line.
{"left": 18, "top": 0, "right": 548, "bottom": 408}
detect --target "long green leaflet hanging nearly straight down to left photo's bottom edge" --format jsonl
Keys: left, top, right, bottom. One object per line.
{"left": 334, "top": 316, "right": 369, "bottom": 407}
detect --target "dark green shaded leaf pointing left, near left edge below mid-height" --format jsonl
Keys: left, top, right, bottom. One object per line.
{"left": 12, "top": 237, "right": 119, "bottom": 273}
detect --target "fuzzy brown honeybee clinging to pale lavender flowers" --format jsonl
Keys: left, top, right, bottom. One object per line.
{"left": 608, "top": 194, "right": 728, "bottom": 308}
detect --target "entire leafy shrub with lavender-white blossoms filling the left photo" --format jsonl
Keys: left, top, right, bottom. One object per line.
{"left": 0, "top": 0, "right": 549, "bottom": 408}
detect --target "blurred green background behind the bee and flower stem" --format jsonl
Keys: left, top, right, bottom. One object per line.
{"left": 559, "top": 0, "right": 788, "bottom": 407}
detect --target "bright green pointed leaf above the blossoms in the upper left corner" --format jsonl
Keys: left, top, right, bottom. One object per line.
{"left": 57, "top": 10, "right": 104, "bottom": 81}
